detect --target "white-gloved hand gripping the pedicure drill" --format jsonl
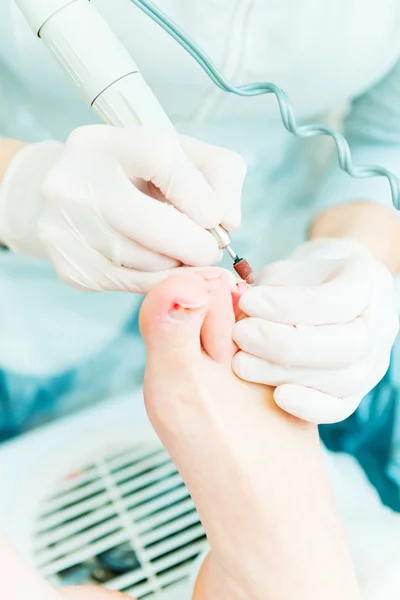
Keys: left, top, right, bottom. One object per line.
{"left": 0, "top": 125, "right": 245, "bottom": 293}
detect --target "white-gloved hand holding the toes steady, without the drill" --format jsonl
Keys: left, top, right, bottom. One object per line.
{"left": 233, "top": 240, "right": 399, "bottom": 423}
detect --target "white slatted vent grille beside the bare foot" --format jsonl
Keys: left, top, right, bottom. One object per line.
{"left": 33, "top": 443, "right": 207, "bottom": 600}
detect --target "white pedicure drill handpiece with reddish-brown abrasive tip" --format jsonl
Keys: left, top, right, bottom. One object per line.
{"left": 17, "top": 0, "right": 254, "bottom": 284}
